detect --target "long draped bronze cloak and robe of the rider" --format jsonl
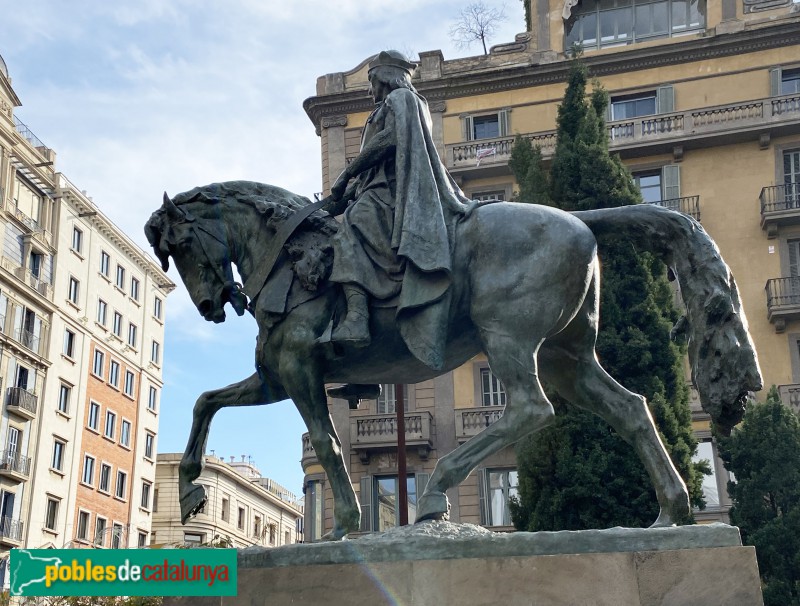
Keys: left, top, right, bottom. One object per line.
{"left": 331, "top": 88, "right": 470, "bottom": 370}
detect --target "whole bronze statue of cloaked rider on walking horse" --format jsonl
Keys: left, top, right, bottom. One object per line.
{"left": 145, "top": 51, "right": 762, "bottom": 539}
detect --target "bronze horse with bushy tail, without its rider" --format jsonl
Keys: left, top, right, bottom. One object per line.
{"left": 145, "top": 181, "right": 761, "bottom": 539}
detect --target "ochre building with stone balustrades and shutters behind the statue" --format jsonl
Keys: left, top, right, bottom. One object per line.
{"left": 302, "top": 0, "right": 800, "bottom": 540}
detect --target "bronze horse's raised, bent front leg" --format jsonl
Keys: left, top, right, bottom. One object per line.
{"left": 178, "top": 372, "right": 289, "bottom": 524}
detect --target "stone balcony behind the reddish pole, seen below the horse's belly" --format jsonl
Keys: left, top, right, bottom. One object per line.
{"left": 350, "top": 410, "right": 433, "bottom": 464}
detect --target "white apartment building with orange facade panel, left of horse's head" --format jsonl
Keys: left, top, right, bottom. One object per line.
{"left": 27, "top": 174, "right": 175, "bottom": 548}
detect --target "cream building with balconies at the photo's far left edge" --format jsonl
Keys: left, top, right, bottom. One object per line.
{"left": 0, "top": 58, "right": 58, "bottom": 558}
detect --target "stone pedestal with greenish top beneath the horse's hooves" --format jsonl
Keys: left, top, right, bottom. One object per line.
{"left": 164, "top": 522, "right": 763, "bottom": 606}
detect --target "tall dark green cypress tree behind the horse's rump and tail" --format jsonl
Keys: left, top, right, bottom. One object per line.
{"left": 511, "top": 59, "right": 710, "bottom": 530}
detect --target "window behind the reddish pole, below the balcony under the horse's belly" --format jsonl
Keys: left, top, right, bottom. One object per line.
{"left": 359, "top": 474, "right": 428, "bottom": 532}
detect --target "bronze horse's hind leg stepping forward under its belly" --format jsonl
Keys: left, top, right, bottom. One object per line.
{"left": 416, "top": 330, "right": 554, "bottom": 522}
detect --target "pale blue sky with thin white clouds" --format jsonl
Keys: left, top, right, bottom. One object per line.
{"left": 0, "top": 0, "right": 525, "bottom": 495}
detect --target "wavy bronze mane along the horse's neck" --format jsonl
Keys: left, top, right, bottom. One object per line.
{"left": 173, "top": 181, "right": 339, "bottom": 291}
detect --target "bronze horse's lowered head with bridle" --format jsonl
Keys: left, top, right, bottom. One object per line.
{"left": 145, "top": 190, "right": 247, "bottom": 323}
